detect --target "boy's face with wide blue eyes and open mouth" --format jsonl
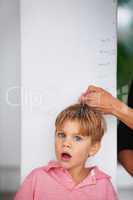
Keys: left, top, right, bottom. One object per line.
{"left": 55, "top": 120, "right": 99, "bottom": 173}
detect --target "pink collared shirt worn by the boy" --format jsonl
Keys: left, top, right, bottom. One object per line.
{"left": 14, "top": 161, "right": 117, "bottom": 200}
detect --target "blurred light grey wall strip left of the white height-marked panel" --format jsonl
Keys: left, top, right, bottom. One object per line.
{"left": 0, "top": 0, "right": 20, "bottom": 190}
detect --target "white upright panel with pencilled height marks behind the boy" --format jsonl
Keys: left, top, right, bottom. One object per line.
{"left": 21, "top": 0, "right": 116, "bottom": 186}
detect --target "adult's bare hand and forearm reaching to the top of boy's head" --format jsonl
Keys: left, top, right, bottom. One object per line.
{"left": 80, "top": 86, "right": 133, "bottom": 129}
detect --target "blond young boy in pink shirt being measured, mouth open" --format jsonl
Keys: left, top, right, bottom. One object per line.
{"left": 15, "top": 104, "right": 117, "bottom": 200}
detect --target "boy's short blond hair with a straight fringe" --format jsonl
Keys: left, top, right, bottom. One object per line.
{"left": 55, "top": 103, "right": 106, "bottom": 142}
